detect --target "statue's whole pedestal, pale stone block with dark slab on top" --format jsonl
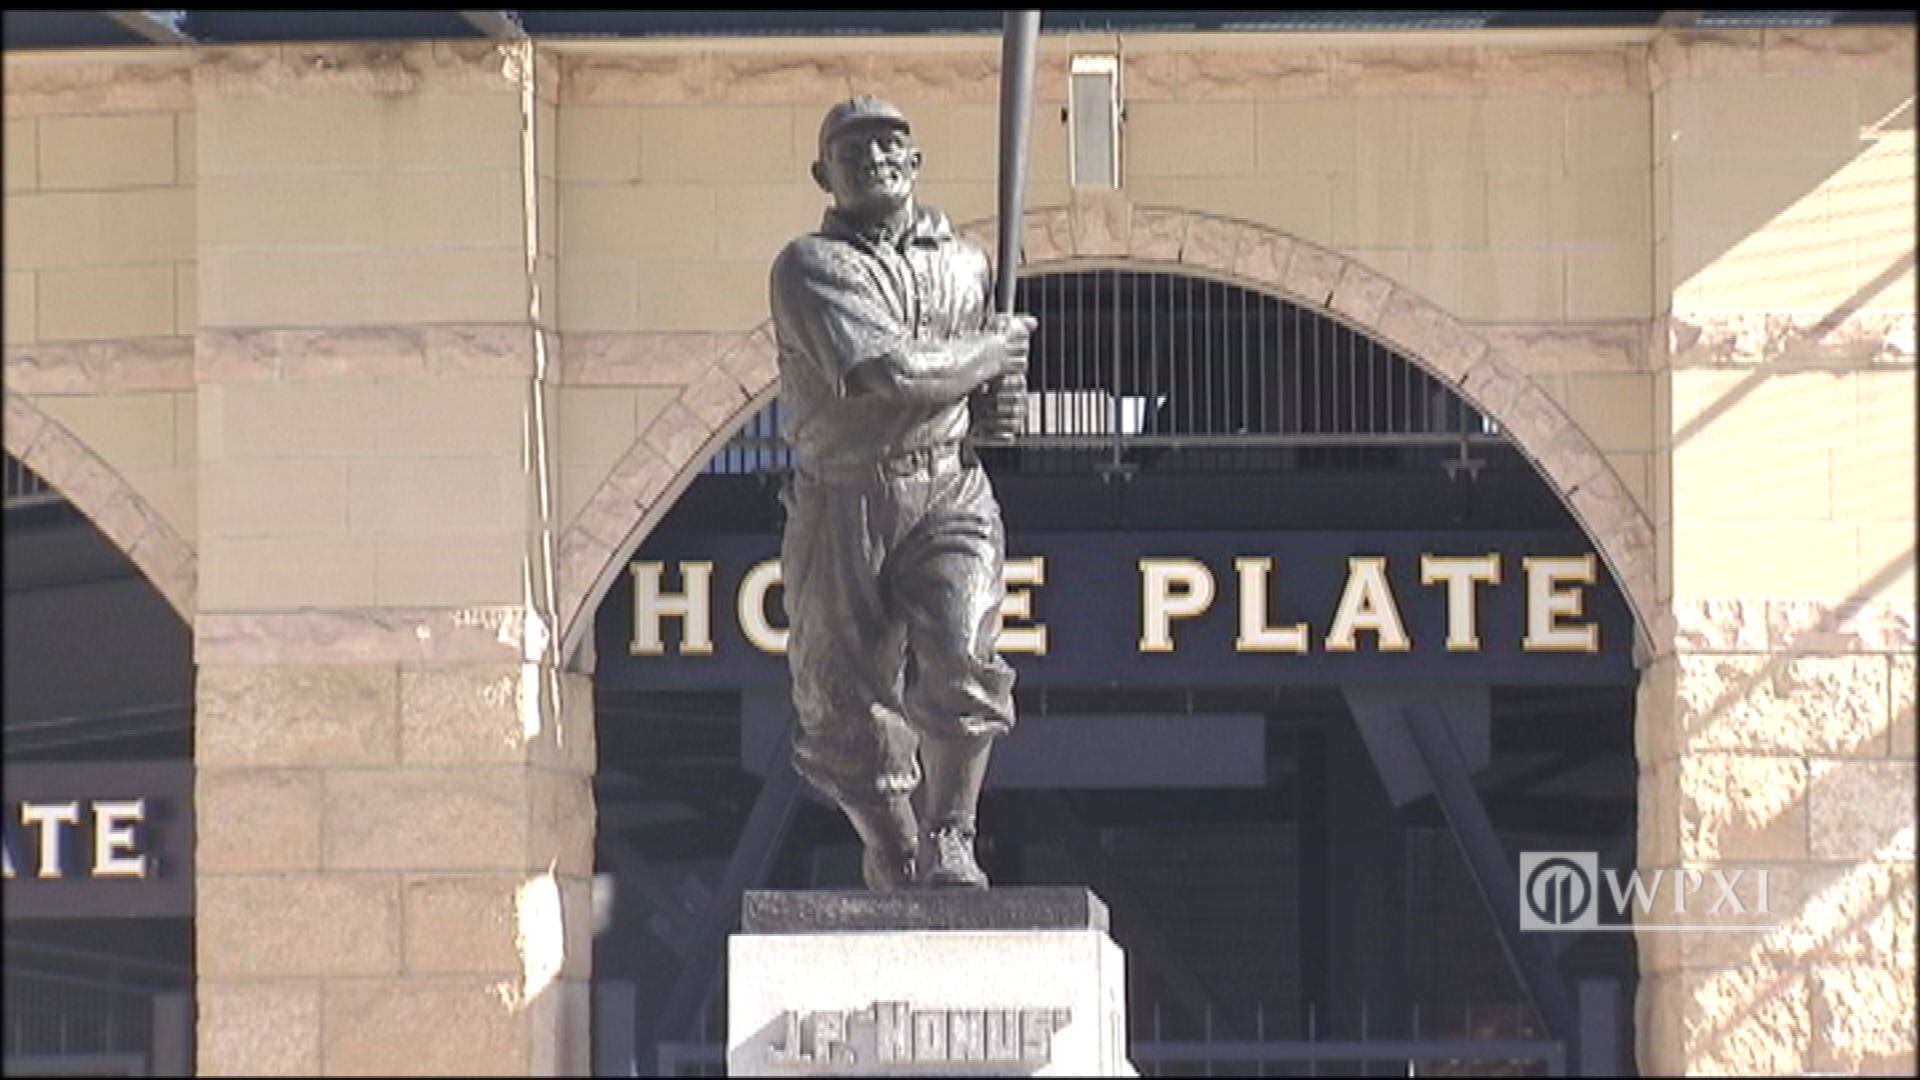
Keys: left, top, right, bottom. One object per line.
{"left": 728, "top": 888, "right": 1135, "bottom": 1076}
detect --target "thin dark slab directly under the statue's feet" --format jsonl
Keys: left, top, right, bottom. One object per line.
{"left": 739, "top": 886, "right": 1108, "bottom": 934}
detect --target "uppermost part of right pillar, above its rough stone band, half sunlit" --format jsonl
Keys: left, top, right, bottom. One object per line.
{"left": 1653, "top": 82, "right": 1914, "bottom": 365}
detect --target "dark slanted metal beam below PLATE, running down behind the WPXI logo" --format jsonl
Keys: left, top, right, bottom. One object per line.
{"left": 1400, "top": 701, "right": 1580, "bottom": 1043}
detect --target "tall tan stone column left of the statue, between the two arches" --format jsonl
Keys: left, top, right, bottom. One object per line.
{"left": 194, "top": 42, "right": 595, "bottom": 1076}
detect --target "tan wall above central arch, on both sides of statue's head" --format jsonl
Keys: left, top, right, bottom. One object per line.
{"left": 557, "top": 35, "right": 1653, "bottom": 331}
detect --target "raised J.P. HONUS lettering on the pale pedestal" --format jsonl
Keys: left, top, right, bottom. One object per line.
{"left": 766, "top": 1001, "right": 1071, "bottom": 1070}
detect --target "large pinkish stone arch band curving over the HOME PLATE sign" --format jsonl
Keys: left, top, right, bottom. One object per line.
{"left": 559, "top": 196, "right": 1659, "bottom": 657}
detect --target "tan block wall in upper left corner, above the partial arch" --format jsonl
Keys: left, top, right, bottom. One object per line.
{"left": 4, "top": 52, "right": 198, "bottom": 544}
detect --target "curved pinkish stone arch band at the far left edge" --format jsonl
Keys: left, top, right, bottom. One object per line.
{"left": 6, "top": 390, "right": 198, "bottom": 626}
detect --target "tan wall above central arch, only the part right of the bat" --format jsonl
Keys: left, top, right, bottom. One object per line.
{"left": 1125, "top": 38, "right": 1651, "bottom": 321}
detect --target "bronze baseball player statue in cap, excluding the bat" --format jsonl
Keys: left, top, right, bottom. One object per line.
{"left": 770, "top": 96, "right": 1035, "bottom": 890}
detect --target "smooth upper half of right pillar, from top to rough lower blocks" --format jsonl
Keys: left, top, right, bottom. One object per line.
{"left": 1655, "top": 33, "right": 1914, "bottom": 601}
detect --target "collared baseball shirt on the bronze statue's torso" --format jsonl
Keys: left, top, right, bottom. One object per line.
{"left": 770, "top": 208, "right": 993, "bottom": 469}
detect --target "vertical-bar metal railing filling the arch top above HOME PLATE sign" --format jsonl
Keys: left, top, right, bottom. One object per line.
{"left": 708, "top": 269, "right": 1505, "bottom": 475}
